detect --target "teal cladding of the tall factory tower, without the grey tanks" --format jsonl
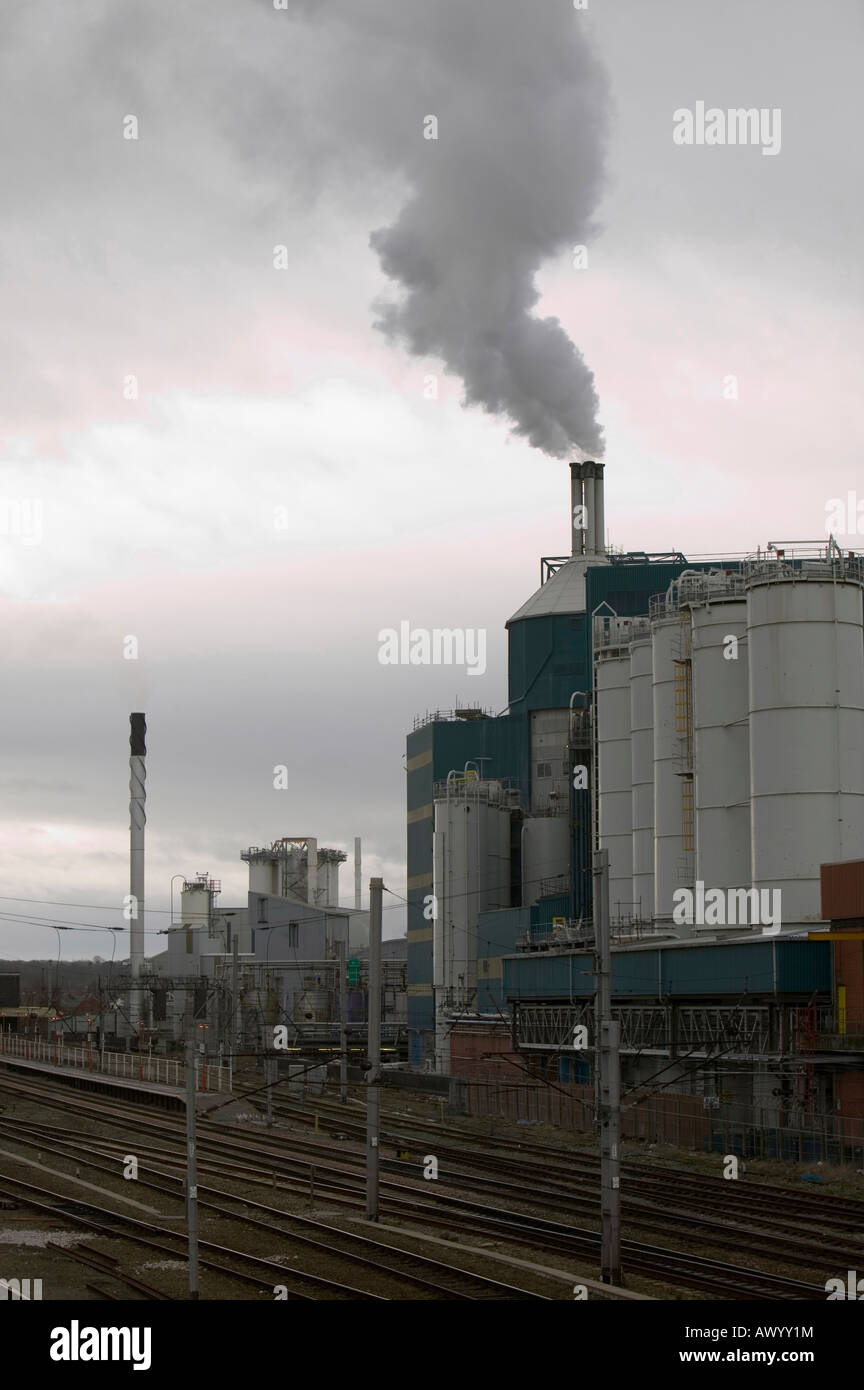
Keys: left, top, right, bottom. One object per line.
{"left": 407, "top": 464, "right": 738, "bottom": 1065}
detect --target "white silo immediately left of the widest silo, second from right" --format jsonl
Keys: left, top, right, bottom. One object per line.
{"left": 690, "top": 594, "right": 750, "bottom": 892}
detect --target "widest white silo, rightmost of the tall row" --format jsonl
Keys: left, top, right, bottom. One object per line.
{"left": 747, "top": 559, "right": 864, "bottom": 924}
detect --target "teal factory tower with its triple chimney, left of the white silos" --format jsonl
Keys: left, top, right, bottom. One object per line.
{"left": 406, "top": 461, "right": 736, "bottom": 1066}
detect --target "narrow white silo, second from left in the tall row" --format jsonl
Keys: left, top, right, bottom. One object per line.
{"left": 631, "top": 635, "right": 654, "bottom": 919}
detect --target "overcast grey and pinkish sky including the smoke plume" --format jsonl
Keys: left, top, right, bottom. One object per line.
{"left": 0, "top": 0, "right": 864, "bottom": 958}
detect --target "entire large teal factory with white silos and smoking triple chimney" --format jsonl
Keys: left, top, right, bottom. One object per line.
{"left": 407, "top": 464, "right": 864, "bottom": 1145}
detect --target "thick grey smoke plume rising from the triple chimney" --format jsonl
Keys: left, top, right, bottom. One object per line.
{"left": 288, "top": 0, "right": 608, "bottom": 456}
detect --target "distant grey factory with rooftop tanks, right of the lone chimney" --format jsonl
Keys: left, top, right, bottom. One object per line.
{"left": 143, "top": 835, "right": 406, "bottom": 1049}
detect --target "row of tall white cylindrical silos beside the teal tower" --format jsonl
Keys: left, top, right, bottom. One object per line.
{"left": 595, "top": 553, "right": 864, "bottom": 937}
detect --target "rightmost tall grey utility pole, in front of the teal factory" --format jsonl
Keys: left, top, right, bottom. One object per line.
{"left": 593, "top": 849, "right": 621, "bottom": 1284}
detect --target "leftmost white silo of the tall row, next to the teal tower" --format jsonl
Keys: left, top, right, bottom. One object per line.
{"left": 595, "top": 646, "right": 633, "bottom": 922}
